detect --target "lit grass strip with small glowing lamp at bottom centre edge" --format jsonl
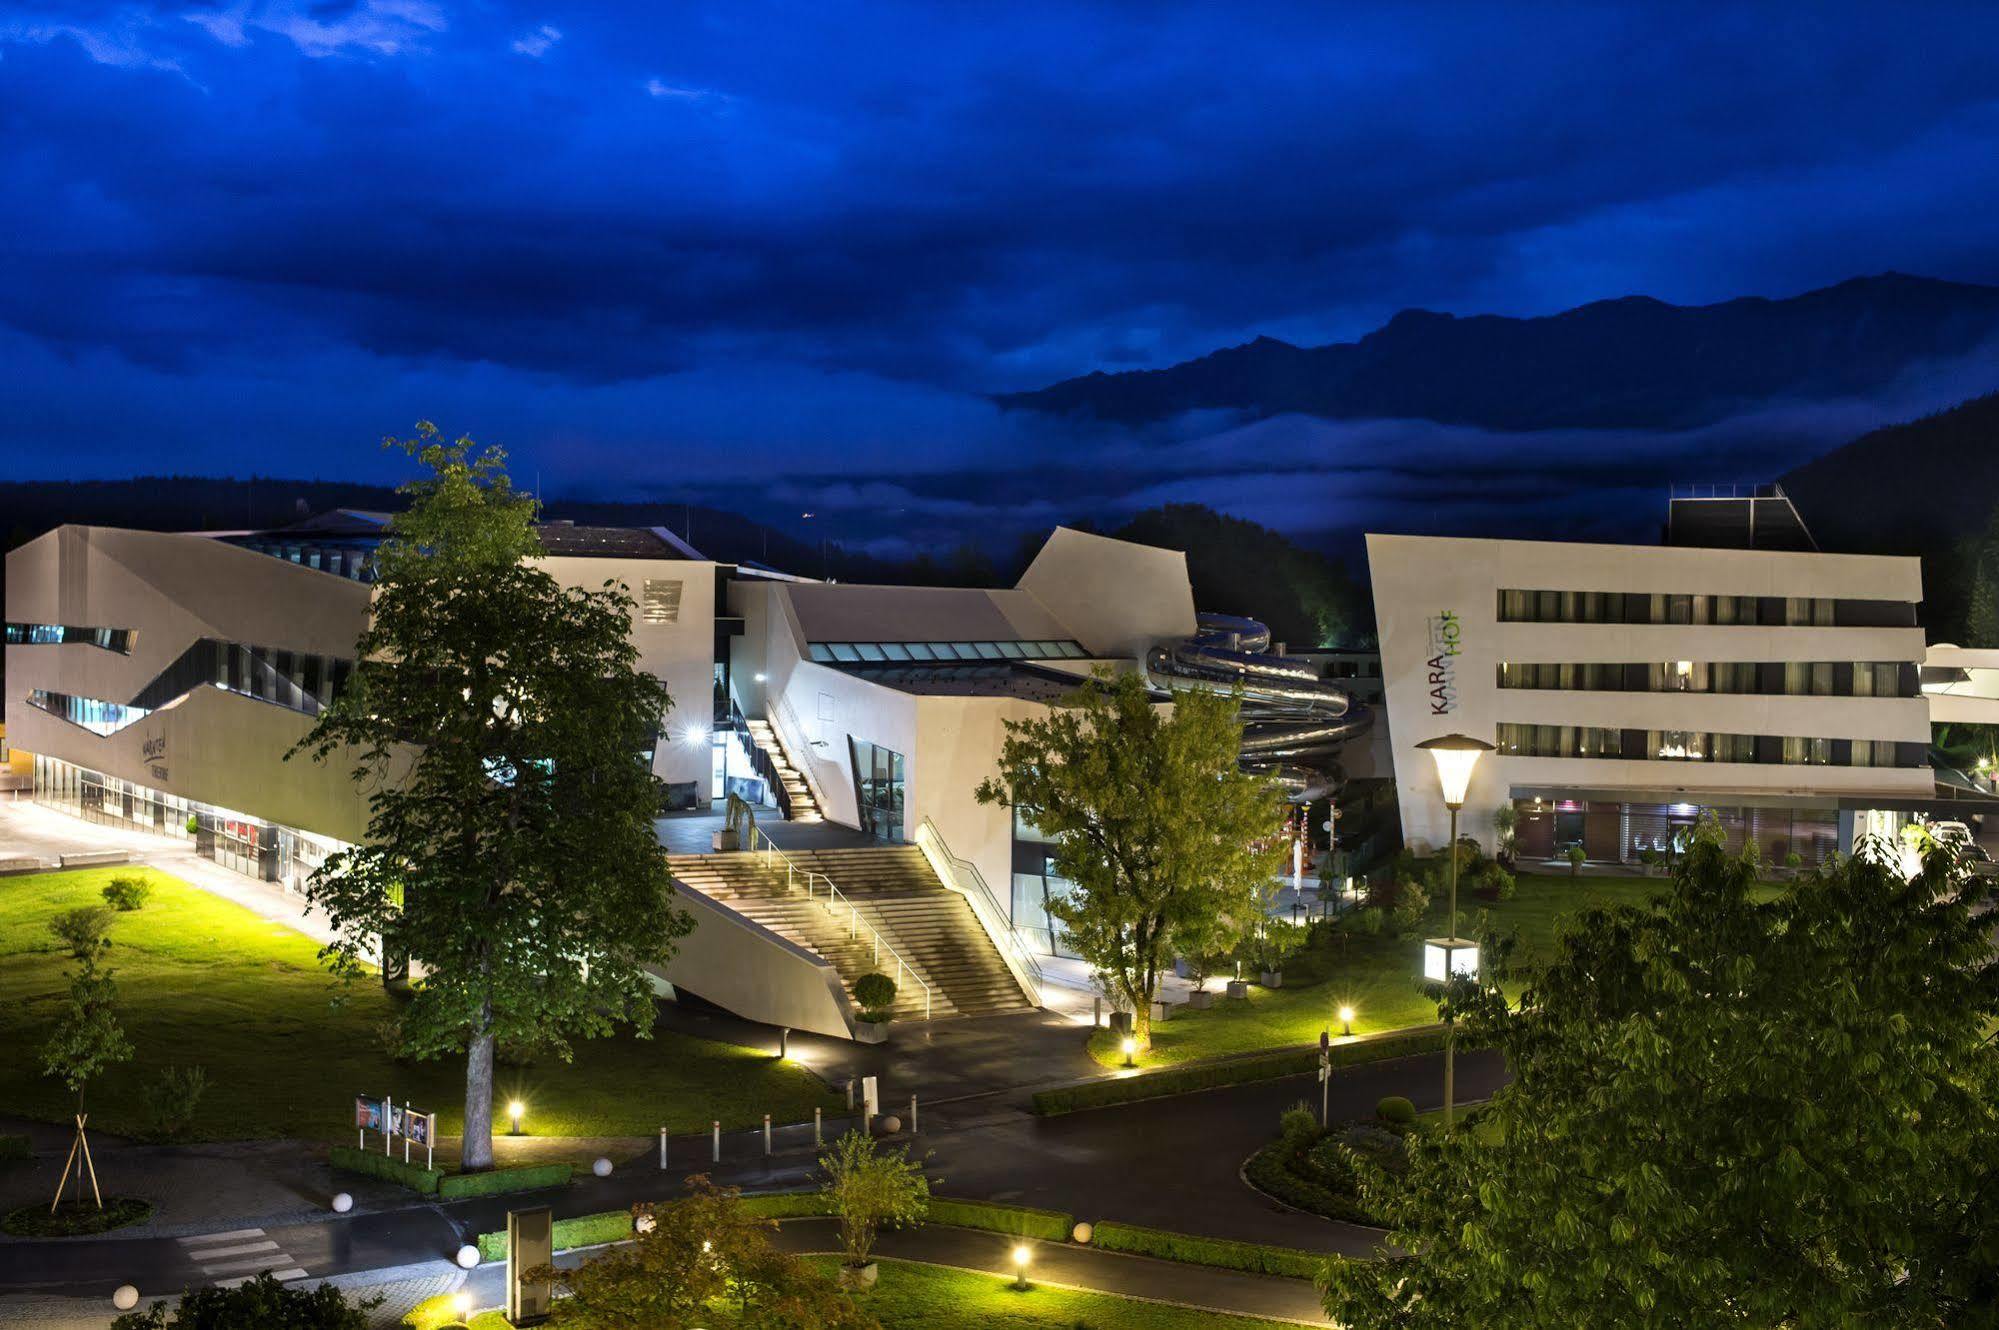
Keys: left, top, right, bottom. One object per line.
{"left": 812, "top": 1256, "right": 1295, "bottom": 1330}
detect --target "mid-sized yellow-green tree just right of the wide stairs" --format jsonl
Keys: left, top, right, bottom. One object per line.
{"left": 978, "top": 672, "right": 1285, "bottom": 1048}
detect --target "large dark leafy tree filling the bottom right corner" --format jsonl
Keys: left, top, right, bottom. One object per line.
{"left": 1325, "top": 822, "right": 1999, "bottom": 1330}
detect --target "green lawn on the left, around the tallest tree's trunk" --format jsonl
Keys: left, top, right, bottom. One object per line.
{"left": 0, "top": 868, "right": 844, "bottom": 1140}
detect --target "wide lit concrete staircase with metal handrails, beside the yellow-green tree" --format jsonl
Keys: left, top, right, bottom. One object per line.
{"left": 668, "top": 846, "right": 1033, "bottom": 1020}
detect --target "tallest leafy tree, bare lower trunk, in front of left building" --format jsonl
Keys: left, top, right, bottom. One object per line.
{"left": 294, "top": 424, "right": 692, "bottom": 1170}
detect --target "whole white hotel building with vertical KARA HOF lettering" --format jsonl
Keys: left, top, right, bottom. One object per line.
{"left": 1367, "top": 492, "right": 1999, "bottom": 864}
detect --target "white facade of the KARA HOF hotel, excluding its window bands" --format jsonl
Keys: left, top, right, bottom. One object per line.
{"left": 1367, "top": 536, "right": 1933, "bottom": 846}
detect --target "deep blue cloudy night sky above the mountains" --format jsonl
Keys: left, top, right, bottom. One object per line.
{"left": 0, "top": 0, "right": 1999, "bottom": 550}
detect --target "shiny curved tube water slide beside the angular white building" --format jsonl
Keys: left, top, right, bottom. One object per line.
{"left": 1145, "top": 614, "right": 1373, "bottom": 802}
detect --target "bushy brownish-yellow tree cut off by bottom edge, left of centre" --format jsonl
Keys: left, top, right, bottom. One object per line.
{"left": 528, "top": 1174, "right": 876, "bottom": 1330}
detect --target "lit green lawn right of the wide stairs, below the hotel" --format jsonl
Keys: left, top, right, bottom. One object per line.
{"left": 1089, "top": 872, "right": 1667, "bottom": 1066}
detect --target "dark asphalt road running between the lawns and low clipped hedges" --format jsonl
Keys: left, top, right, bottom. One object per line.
{"left": 0, "top": 1052, "right": 1505, "bottom": 1294}
